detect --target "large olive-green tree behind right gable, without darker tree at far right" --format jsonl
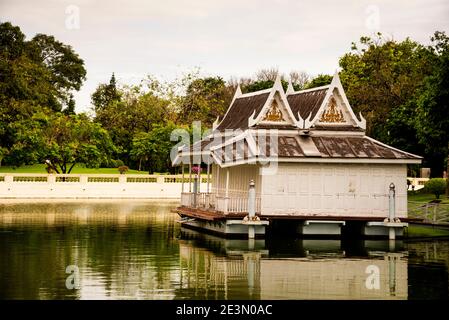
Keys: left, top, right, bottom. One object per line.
{"left": 340, "top": 33, "right": 431, "bottom": 141}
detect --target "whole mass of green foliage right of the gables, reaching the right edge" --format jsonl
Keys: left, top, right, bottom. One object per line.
{"left": 340, "top": 33, "right": 449, "bottom": 176}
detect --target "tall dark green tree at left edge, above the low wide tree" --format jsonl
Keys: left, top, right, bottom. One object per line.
{"left": 0, "top": 22, "right": 86, "bottom": 164}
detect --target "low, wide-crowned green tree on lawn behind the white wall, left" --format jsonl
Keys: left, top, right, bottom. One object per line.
{"left": 8, "top": 113, "right": 116, "bottom": 173}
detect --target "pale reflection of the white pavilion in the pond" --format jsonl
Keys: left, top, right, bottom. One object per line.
{"left": 178, "top": 229, "right": 408, "bottom": 299}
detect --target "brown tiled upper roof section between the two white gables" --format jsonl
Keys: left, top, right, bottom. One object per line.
{"left": 287, "top": 88, "right": 328, "bottom": 120}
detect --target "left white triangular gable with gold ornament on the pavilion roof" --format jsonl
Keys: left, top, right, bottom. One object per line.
{"left": 248, "top": 75, "right": 298, "bottom": 127}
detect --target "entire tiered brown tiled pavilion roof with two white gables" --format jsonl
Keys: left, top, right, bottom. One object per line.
{"left": 173, "top": 73, "right": 422, "bottom": 167}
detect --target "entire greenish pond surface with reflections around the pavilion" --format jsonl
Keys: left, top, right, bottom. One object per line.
{"left": 0, "top": 200, "right": 449, "bottom": 299}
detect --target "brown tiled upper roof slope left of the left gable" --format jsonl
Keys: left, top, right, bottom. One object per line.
{"left": 217, "top": 92, "right": 270, "bottom": 131}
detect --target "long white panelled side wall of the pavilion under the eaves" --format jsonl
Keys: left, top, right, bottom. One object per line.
{"left": 261, "top": 163, "right": 407, "bottom": 217}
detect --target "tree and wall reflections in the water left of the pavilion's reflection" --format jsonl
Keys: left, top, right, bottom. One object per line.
{"left": 0, "top": 203, "right": 179, "bottom": 299}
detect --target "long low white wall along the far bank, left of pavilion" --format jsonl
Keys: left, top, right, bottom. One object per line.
{"left": 0, "top": 174, "right": 207, "bottom": 199}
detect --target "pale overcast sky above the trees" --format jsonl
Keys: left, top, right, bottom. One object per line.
{"left": 0, "top": 0, "right": 449, "bottom": 111}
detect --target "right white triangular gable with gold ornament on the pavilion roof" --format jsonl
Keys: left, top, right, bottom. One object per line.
{"left": 298, "top": 71, "right": 366, "bottom": 130}
